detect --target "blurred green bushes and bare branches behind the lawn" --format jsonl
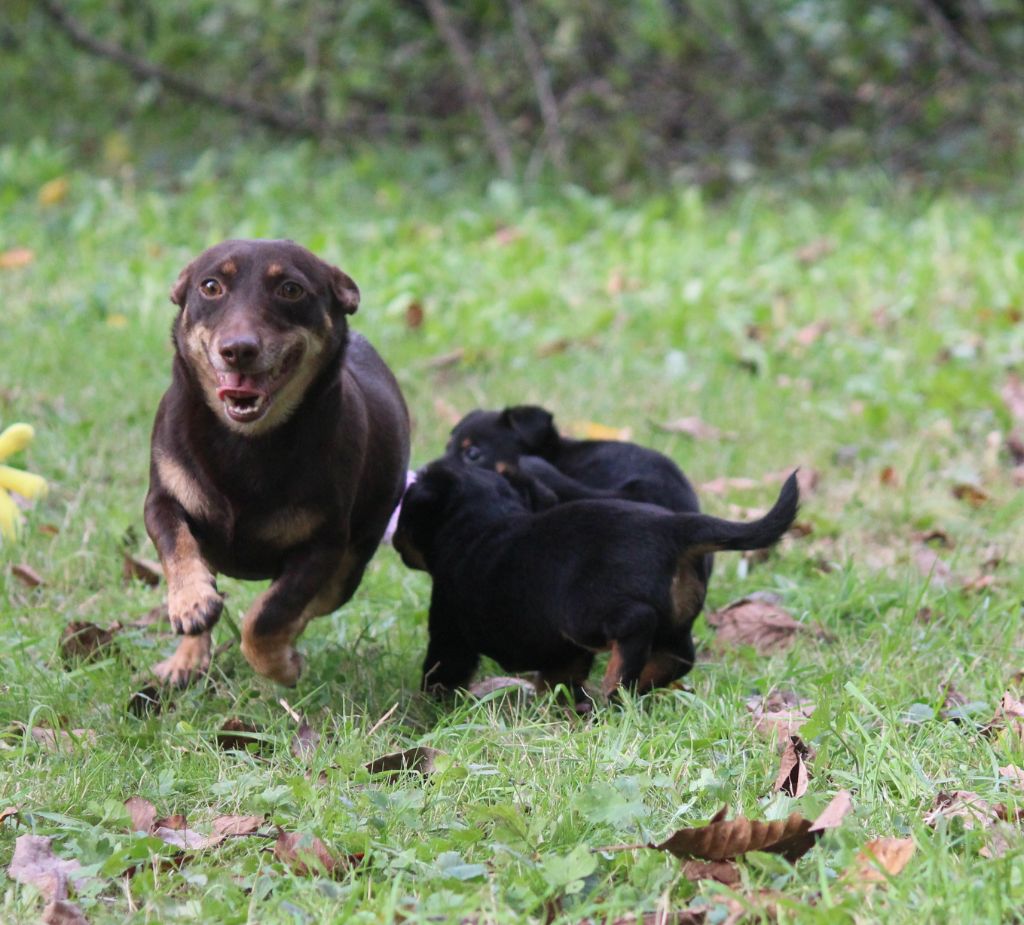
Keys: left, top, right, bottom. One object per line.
{"left": 6, "top": 0, "right": 1024, "bottom": 190}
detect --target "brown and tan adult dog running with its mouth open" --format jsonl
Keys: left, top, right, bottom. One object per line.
{"left": 145, "top": 241, "right": 409, "bottom": 684}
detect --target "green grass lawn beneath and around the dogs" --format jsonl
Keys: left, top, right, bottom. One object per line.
{"left": 0, "top": 144, "right": 1024, "bottom": 925}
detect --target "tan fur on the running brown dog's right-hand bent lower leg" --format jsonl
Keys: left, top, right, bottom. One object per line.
{"left": 242, "top": 552, "right": 355, "bottom": 687}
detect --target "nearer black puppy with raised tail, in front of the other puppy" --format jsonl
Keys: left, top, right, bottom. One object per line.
{"left": 394, "top": 460, "right": 799, "bottom": 693}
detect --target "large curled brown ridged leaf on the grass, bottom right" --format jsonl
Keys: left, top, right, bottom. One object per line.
{"left": 648, "top": 791, "right": 851, "bottom": 863}
